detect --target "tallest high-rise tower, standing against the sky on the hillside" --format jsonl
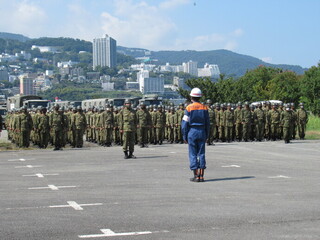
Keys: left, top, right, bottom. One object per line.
{"left": 93, "top": 34, "right": 117, "bottom": 69}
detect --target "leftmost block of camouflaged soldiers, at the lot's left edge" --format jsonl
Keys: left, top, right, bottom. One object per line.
{"left": 5, "top": 105, "right": 86, "bottom": 150}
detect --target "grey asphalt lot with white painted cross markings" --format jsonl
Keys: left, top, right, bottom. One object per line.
{"left": 0, "top": 130, "right": 320, "bottom": 240}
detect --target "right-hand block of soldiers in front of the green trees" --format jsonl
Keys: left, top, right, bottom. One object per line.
{"left": 207, "top": 100, "right": 308, "bottom": 144}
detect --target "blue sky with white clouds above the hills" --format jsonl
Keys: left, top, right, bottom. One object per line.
{"left": 0, "top": 0, "right": 320, "bottom": 67}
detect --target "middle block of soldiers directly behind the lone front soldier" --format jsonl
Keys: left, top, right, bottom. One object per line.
{"left": 86, "top": 103, "right": 184, "bottom": 147}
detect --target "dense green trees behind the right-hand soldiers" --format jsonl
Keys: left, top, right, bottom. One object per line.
{"left": 178, "top": 63, "right": 320, "bottom": 115}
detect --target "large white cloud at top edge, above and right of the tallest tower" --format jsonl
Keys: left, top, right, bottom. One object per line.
{"left": 101, "top": 0, "right": 176, "bottom": 50}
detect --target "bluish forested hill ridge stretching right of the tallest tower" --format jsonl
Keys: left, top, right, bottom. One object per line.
{"left": 118, "top": 46, "right": 307, "bottom": 77}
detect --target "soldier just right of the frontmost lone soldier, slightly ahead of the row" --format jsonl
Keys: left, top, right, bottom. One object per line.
{"left": 136, "top": 103, "right": 151, "bottom": 148}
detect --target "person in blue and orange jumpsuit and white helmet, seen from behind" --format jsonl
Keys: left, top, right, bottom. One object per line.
{"left": 181, "top": 88, "right": 210, "bottom": 182}
